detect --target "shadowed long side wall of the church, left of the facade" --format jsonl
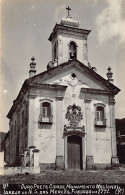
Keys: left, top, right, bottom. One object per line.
{"left": 9, "top": 94, "right": 28, "bottom": 166}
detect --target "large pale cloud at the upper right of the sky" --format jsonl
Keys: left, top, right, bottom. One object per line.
{"left": 96, "top": 0, "right": 125, "bottom": 44}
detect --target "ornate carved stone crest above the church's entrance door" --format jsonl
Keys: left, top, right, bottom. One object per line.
{"left": 64, "top": 104, "right": 85, "bottom": 132}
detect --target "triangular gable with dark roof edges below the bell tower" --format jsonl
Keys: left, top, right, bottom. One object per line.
{"left": 27, "top": 60, "right": 120, "bottom": 94}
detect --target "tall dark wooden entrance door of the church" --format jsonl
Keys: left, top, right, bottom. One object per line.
{"left": 67, "top": 135, "right": 82, "bottom": 169}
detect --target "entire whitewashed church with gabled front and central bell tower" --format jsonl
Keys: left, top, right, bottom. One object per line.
{"left": 4, "top": 9, "right": 120, "bottom": 169}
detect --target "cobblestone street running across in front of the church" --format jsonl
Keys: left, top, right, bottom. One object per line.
{"left": 0, "top": 169, "right": 125, "bottom": 184}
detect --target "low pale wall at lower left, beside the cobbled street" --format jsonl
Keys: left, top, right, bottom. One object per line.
{"left": 0, "top": 166, "right": 40, "bottom": 175}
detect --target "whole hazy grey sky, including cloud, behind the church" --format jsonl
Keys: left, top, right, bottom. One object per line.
{"left": 0, "top": 0, "right": 125, "bottom": 132}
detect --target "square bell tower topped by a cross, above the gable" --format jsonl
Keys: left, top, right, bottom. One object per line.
{"left": 48, "top": 7, "right": 91, "bottom": 66}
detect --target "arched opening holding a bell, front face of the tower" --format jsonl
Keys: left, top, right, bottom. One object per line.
{"left": 69, "top": 41, "right": 77, "bottom": 59}
